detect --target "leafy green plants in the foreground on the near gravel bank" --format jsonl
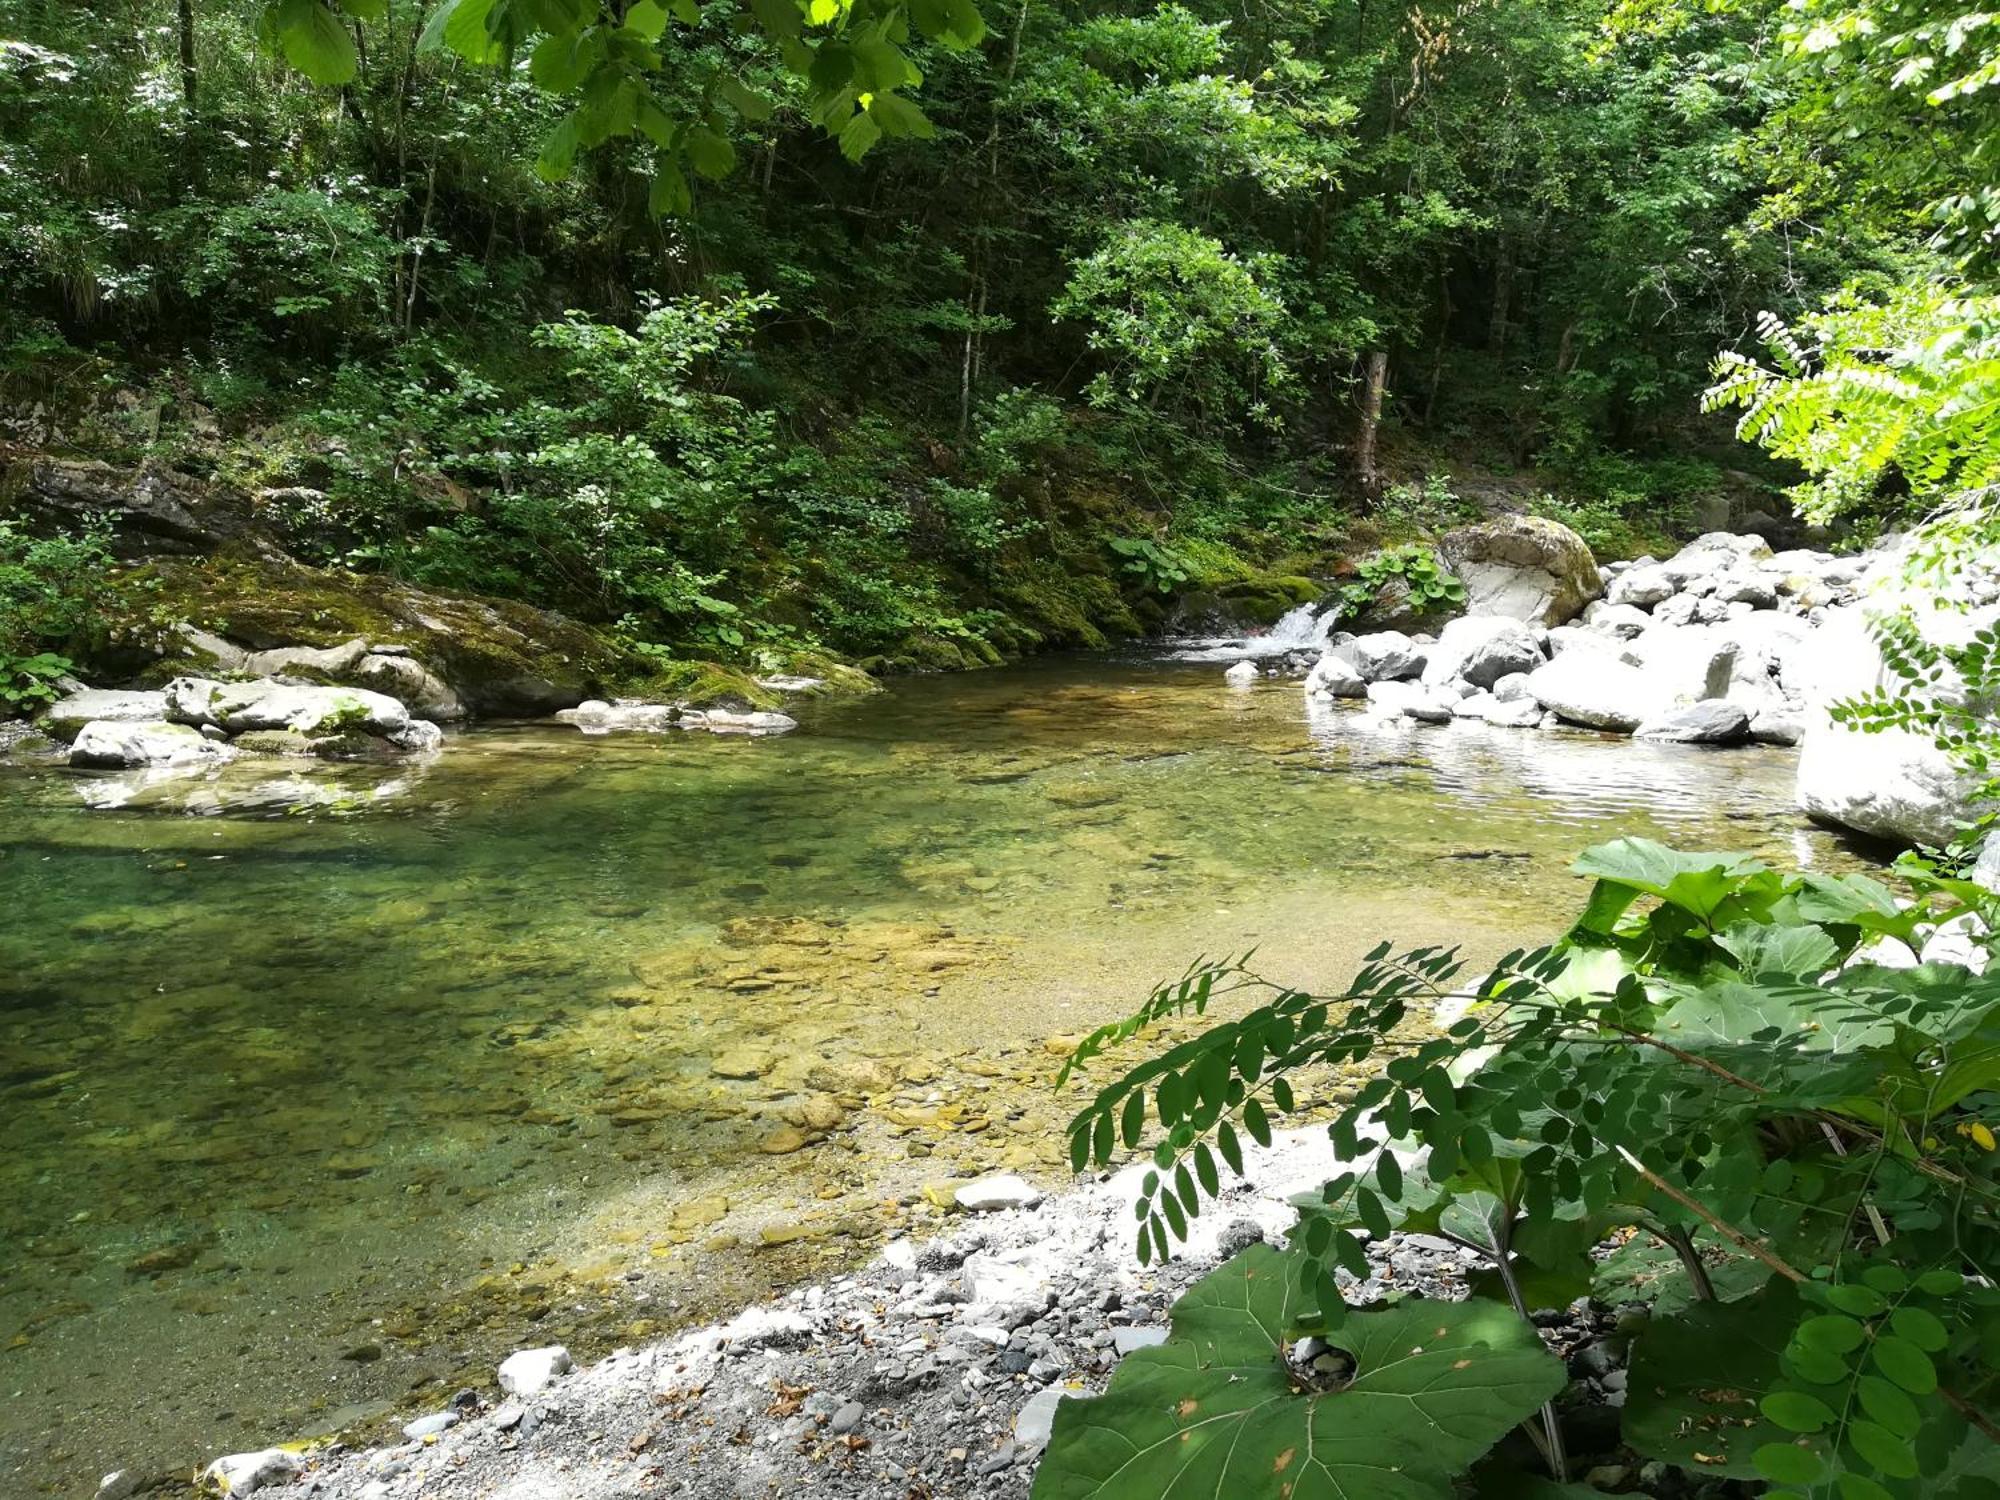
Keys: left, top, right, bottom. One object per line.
{"left": 1036, "top": 840, "right": 2000, "bottom": 1500}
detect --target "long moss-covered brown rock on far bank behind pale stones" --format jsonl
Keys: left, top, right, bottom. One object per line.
{"left": 114, "top": 558, "right": 626, "bottom": 716}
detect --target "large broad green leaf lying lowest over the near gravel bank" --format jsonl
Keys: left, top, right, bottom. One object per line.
{"left": 1034, "top": 1246, "right": 1564, "bottom": 1500}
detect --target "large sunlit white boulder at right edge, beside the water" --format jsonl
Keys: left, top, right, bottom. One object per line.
{"left": 1798, "top": 588, "right": 2000, "bottom": 844}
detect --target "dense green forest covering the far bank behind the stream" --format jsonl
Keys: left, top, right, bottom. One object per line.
{"left": 0, "top": 0, "right": 1976, "bottom": 664}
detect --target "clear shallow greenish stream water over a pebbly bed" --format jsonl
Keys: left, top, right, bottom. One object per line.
{"left": 0, "top": 660, "right": 1846, "bottom": 1494}
